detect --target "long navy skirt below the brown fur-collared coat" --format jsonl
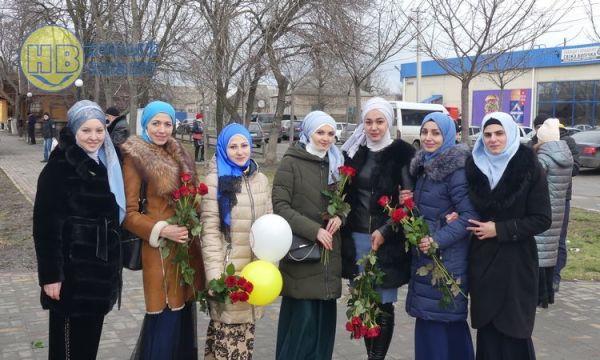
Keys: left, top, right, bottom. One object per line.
{"left": 131, "top": 303, "right": 198, "bottom": 360}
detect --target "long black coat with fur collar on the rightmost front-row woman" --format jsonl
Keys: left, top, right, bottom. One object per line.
{"left": 465, "top": 145, "right": 551, "bottom": 338}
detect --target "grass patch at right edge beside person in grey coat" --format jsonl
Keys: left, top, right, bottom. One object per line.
{"left": 561, "top": 208, "right": 600, "bottom": 281}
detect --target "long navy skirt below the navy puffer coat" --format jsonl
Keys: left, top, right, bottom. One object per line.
{"left": 415, "top": 319, "right": 475, "bottom": 360}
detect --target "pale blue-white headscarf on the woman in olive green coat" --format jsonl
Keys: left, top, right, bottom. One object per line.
{"left": 300, "top": 111, "right": 344, "bottom": 184}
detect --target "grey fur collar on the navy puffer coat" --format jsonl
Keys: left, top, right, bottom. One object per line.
{"left": 410, "top": 144, "right": 471, "bottom": 181}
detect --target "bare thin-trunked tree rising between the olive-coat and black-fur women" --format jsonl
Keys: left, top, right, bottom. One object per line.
{"left": 320, "top": 0, "right": 412, "bottom": 121}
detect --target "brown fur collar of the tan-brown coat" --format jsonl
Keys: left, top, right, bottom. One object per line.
{"left": 121, "top": 136, "right": 198, "bottom": 196}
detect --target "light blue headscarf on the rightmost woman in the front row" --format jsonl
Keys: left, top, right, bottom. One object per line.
{"left": 473, "top": 112, "right": 520, "bottom": 189}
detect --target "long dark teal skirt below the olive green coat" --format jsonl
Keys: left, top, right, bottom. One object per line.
{"left": 275, "top": 296, "right": 337, "bottom": 360}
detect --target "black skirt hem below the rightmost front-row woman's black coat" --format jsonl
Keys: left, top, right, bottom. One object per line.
{"left": 475, "top": 323, "right": 535, "bottom": 360}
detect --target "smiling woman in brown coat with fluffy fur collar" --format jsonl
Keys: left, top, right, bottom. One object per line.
{"left": 121, "top": 101, "right": 204, "bottom": 360}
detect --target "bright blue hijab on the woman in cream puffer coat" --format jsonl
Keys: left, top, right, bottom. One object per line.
{"left": 215, "top": 123, "right": 252, "bottom": 229}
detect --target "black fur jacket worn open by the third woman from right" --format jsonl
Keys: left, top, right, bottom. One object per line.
{"left": 342, "top": 139, "right": 415, "bottom": 288}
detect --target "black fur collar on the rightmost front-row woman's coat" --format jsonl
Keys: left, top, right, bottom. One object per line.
{"left": 465, "top": 145, "right": 540, "bottom": 213}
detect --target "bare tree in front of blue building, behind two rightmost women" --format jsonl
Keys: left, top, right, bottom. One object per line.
{"left": 421, "top": 0, "right": 568, "bottom": 141}
